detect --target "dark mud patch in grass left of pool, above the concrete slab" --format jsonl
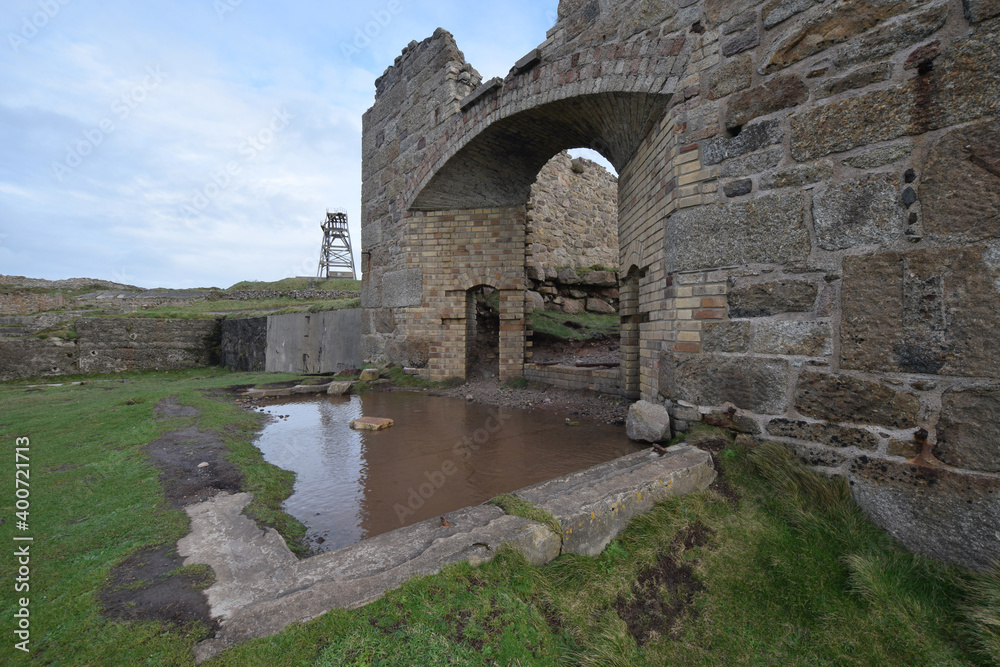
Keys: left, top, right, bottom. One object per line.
{"left": 146, "top": 426, "right": 243, "bottom": 509}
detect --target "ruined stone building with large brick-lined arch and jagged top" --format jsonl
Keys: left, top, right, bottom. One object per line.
{"left": 362, "top": 0, "right": 1000, "bottom": 566}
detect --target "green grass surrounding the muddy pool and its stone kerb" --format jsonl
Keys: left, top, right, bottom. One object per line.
{"left": 0, "top": 369, "right": 1000, "bottom": 667}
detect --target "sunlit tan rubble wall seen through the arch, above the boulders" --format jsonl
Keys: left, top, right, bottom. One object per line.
{"left": 527, "top": 152, "right": 618, "bottom": 271}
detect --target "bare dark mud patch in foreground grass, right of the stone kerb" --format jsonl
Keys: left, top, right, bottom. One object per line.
{"left": 614, "top": 523, "right": 712, "bottom": 646}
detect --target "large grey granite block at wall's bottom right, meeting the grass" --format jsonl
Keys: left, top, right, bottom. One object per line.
{"left": 849, "top": 457, "right": 1000, "bottom": 569}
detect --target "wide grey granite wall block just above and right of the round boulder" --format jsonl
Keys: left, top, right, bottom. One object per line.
{"left": 660, "top": 352, "right": 788, "bottom": 415}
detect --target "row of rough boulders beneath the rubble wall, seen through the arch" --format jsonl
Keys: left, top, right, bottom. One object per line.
{"left": 527, "top": 267, "right": 621, "bottom": 315}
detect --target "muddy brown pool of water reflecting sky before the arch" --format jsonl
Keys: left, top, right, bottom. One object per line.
{"left": 256, "top": 392, "right": 638, "bottom": 550}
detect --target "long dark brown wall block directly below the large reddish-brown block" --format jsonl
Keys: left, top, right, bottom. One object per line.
{"left": 795, "top": 371, "right": 920, "bottom": 428}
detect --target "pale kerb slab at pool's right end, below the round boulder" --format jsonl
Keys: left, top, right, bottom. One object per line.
{"left": 514, "top": 447, "right": 716, "bottom": 556}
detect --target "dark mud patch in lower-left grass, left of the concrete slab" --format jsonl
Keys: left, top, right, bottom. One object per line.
{"left": 99, "top": 547, "right": 218, "bottom": 636}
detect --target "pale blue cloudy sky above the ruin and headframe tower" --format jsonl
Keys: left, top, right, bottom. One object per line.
{"left": 0, "top": 0, "right": 608, "bottom": 288}
